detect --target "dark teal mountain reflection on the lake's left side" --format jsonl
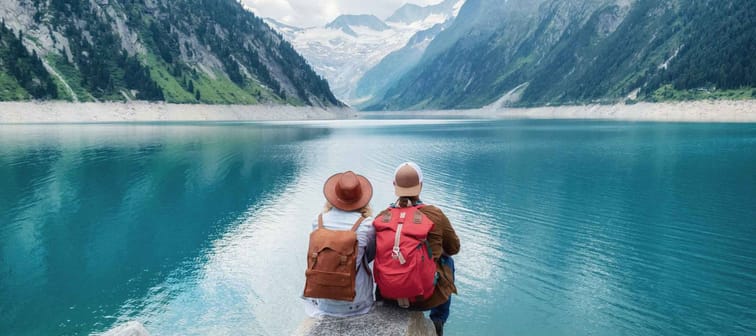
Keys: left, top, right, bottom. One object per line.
{"left": 0, "top": 125, "right": 327, "bottom": 334}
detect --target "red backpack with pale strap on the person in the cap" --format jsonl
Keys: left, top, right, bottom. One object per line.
{"left": 373, "top": 205, "right": 436, "bottom": 307}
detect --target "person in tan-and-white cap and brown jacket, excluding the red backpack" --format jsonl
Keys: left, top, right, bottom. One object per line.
{"left": 376, "top": 162, "right": 460, "bottom": 335}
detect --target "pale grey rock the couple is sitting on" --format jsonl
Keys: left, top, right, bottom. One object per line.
{"left": 294, "top": 302, "right": 436, "bottom": 336}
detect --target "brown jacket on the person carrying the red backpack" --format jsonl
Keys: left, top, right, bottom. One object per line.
{"left": 376, "top": 205, "right": 460, "bottom": 309}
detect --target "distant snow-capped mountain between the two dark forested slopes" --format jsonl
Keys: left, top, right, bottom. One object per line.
{"left": 266, "top": 0, "right": 464, "bottom": 105}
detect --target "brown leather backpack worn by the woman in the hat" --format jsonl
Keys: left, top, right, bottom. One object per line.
{"left": 304, "top": 214, "right": 369, "bottom": 301}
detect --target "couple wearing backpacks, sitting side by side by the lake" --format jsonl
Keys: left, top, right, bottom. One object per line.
{"left": 303, "top": 162, "right": 460, "bottom": 335}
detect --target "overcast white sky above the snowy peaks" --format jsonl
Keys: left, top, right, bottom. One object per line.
{"left": 242, "top": 0, "right": 442, "bottom": 27}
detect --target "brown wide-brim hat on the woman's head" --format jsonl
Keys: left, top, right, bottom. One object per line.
{"left": 323, "top": 171, "right": 373, "bottom": 211}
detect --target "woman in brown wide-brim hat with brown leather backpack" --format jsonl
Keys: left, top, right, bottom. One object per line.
{"left": 303, "top": 171, "right": 375, "bottom": 317}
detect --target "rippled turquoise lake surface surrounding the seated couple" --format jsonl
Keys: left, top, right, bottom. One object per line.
{"left": 0, "top": 120, "right": 756, "bottom": 336}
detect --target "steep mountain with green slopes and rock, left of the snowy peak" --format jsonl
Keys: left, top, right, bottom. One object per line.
{"left": 0, "top": 0, "right": 342, "bottom": 107}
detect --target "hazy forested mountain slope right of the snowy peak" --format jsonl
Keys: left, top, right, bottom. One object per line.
{"left": 367, "top": 0, "right": 756, "bottom": 110}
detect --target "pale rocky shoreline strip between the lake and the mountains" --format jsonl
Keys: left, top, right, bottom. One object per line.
{"left": 0, "top": 100, "right": 756, "bottom": 124}
